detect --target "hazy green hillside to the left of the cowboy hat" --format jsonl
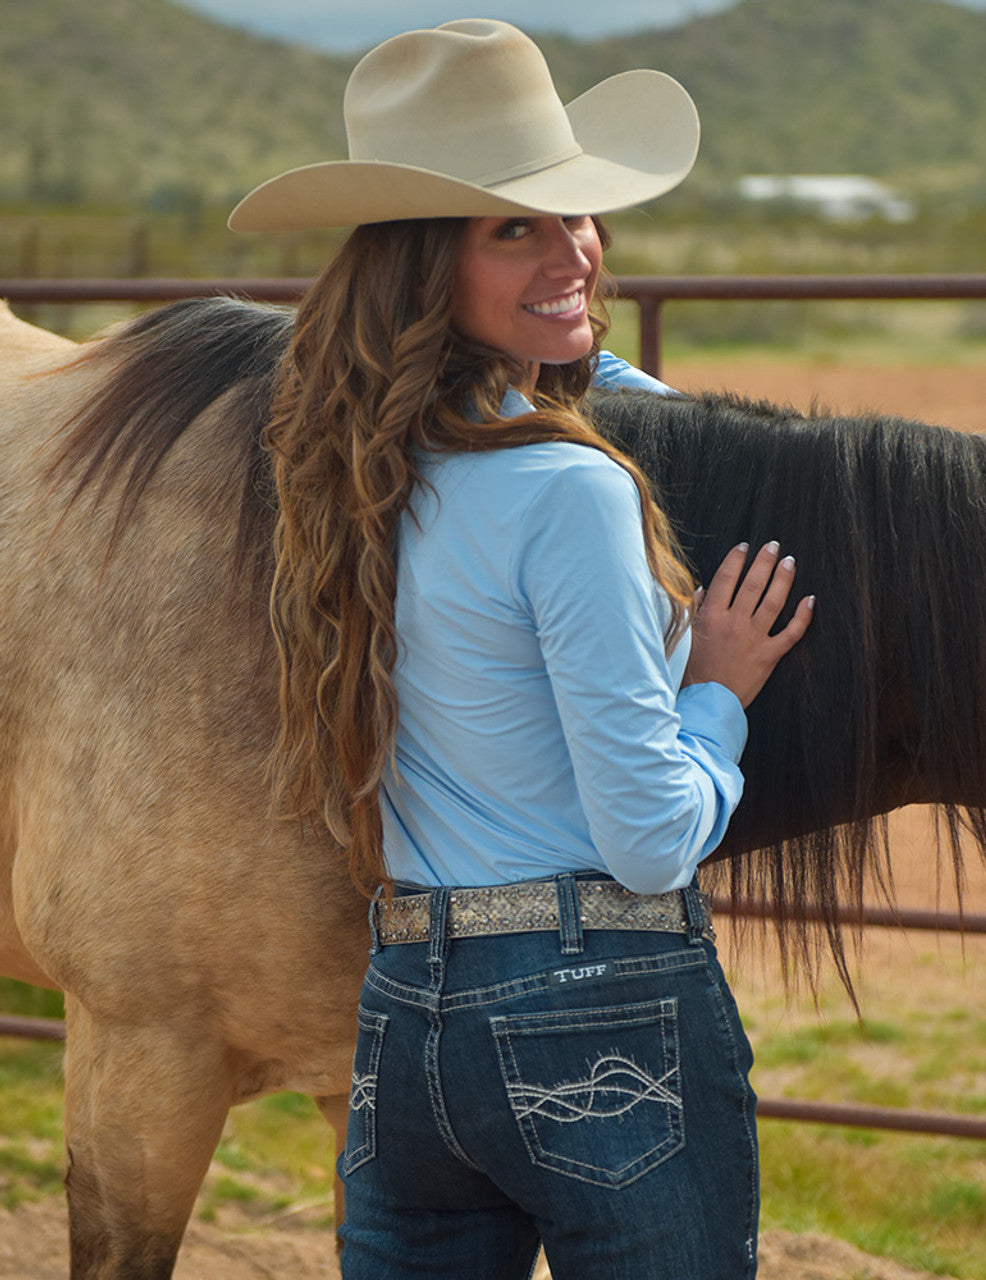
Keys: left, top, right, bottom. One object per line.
{"left": 0, "top": 0, "right": 353, "bottom": 207}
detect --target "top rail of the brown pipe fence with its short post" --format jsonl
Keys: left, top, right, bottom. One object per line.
{"left": 7, "top": 273, "right": 986, "bottom": 378}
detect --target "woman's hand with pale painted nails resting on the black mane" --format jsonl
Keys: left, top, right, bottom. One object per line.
{"left": 683, "top": 543, "right": 814, "bottom": 707}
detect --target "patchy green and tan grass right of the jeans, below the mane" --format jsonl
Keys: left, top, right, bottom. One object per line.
{"left": 727, "top": 931, "right": 986, "bottom": 1280}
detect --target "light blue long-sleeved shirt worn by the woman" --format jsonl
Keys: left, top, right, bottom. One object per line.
{"left": 380, "top": 345, "right": 747, "bottom": 893}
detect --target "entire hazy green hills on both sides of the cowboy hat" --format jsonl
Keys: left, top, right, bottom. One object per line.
{"left": 0, "top": 0, "right": 986, "bottom": 209}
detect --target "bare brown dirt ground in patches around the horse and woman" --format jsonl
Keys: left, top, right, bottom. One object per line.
{"left": 0, "top": 361, "right": 986, "bottom": 1280}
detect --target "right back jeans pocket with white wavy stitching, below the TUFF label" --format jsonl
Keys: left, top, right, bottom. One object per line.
{"left": 490, "top": 998, "right": 685, "bottom": 1187}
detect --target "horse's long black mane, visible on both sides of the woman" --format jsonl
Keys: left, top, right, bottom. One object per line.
{"left": 49, "top": 298, "right": 986, "bottom": 991}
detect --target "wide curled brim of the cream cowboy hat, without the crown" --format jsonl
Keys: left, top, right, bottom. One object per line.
{"left": 229, "top": 70, "right": 699, "bottom": 232}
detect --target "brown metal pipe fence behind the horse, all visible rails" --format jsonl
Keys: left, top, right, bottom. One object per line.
{"left": 0, "top": 274, "right": 986, "bottom": 1140}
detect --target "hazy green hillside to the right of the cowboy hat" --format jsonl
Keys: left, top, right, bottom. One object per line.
{"left": 546, "top": 0, "right": 986, "bottom": 189}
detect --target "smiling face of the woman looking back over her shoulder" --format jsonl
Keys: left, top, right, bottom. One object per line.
{"left": 452, "top": 216, "right": 603, "bottom": 389}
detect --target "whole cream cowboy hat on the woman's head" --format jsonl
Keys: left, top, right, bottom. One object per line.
{"left": 229, "top": 18, "right": 699, "bottom": 232}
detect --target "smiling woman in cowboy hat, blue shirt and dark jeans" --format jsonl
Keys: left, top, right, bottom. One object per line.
{"left": 230, "top": 19, "right": 812, "bottom": 1280}
